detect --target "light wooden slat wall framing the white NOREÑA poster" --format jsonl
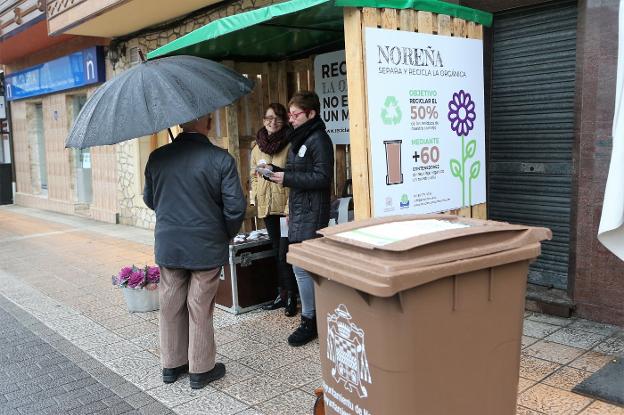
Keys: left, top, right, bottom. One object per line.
{"left": 344, "top": 7, "right": 487, "bottom": 219}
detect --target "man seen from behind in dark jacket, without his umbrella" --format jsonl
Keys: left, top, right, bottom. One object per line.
{"left": 143, "top": 115, "right": 246, "bottom": 389}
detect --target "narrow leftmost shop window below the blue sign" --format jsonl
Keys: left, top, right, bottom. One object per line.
{"left": 26, "top": 103, "right": 48, "bottom": 195}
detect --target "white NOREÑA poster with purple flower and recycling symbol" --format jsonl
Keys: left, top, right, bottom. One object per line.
{"left": 365, "top": 28, "right": 486, "bottom": 216}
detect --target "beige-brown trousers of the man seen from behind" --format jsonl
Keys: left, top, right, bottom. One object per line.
{"left": 158, "top": 267, "right": 221, "bottom": 373}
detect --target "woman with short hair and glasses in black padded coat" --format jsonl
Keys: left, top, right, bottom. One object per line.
{"left": 271, "top": 91, "right": 334, "bottom": 346}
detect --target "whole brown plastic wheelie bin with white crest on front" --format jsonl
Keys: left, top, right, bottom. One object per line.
{"left": 288, "top": 215, "right": 552, "bottom": 415}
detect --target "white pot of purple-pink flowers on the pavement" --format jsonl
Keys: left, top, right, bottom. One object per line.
{"left": 113, "top": 265, "right": 160, "bottom": 313}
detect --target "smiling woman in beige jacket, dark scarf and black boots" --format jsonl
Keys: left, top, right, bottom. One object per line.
{"left": 250, "top": 103, "right": 297, "bottom": 317}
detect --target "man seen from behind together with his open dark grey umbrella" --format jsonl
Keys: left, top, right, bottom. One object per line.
{"left": 65, "top": 56, "right": 254, "bottom": 389}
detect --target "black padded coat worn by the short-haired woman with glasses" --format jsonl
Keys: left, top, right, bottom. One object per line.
{"left": 284, "top": 116, "right": 334, "bottom": 242}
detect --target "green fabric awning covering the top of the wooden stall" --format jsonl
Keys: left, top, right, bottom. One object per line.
{"left": 147, "top": 0, "right": 492, "bottom": 62}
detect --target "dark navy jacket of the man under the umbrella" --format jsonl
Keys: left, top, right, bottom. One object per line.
{"left": 143, "top": 133, "right": 246, "bottom": 270}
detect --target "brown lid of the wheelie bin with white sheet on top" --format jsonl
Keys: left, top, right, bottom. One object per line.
{"left": 288, "top": 214, "right": 552, "bottom": 297}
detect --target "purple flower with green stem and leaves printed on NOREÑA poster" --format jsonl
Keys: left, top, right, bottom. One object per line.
{"left": 448, "top": 89, "right": 481, "bottom": 206}
